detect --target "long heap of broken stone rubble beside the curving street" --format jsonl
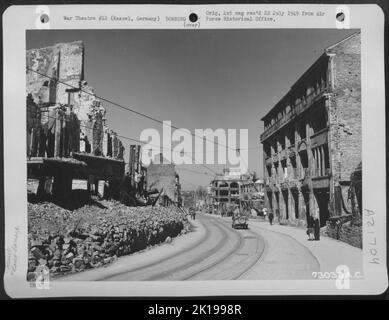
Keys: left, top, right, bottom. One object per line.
{"left": 28, "top": 201, "right": 189, "bottom": 280}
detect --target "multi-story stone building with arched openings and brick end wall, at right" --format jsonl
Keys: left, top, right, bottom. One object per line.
{"left": 260, "top": 32, "right": 362, "bottom": 227}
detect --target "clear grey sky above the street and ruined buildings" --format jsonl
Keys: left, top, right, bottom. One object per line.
{"left": 26, "top": 29, "right": 355, "bottom": 190}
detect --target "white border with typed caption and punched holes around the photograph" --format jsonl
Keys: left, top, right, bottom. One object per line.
{"left": 3, "top": 4, "right": 388, "bottom": 298}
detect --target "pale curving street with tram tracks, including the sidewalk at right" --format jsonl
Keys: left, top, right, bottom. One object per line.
{"left": 59, "top": 214, "right": 362, "bottom": 281}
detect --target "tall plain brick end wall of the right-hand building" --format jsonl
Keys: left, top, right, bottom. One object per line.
{"left": 329, "top": 33, "right": 362, "bottom": 181}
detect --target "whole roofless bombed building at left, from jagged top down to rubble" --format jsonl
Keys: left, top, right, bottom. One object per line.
{"left": 26, "top": 41, "right": 124, "bottom": 195}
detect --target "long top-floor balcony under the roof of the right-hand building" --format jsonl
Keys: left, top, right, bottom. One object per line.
{"left": 260, "top": 88, "right": 327, "bottom": 142}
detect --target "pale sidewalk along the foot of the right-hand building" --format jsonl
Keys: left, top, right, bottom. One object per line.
{"left": 249, "top": 220, "right": 363, "bottom": 274}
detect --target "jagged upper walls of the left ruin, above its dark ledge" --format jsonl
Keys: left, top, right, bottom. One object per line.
{"left": 26, "top": 41, "right": 124, "bottom": 159}
